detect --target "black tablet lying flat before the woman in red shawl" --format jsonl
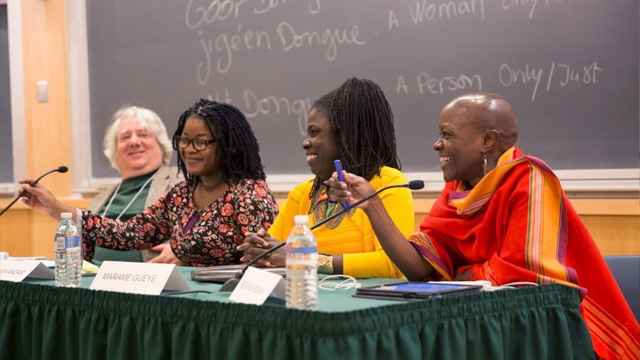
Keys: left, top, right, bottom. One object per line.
{"left": 354, "top": 282, "right": 482, "bottom": 300}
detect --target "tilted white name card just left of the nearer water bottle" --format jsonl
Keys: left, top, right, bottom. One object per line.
{"left": 229, "top": 266, "right": 285, "bottom": 305}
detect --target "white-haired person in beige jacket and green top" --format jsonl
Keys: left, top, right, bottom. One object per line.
{"left": 89, "top": 106, "right": 183, "bottom": 264}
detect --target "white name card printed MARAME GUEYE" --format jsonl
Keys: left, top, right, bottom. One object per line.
{"left": 89, "top": 261, "right": 190, "bottom": 295}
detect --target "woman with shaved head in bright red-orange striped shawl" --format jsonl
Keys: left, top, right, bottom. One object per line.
{"left": 328, "top": 93, "right": 640, "bottom": 359}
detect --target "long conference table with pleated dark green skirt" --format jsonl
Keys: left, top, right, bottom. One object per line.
{"left": 0, "top": 267, "right": 593, "bottom": 360}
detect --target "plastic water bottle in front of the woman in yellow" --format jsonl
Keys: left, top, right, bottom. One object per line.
{"left": 286, "top": 215, "right": 318, "bottom": 310}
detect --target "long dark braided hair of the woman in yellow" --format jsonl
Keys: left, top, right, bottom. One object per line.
{"left": 310, "top": 78, "right": 402, "bottom": 196}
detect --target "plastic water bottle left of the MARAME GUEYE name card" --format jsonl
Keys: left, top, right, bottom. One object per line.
{"left": 54, "top": 213, "right": 82, "bottom": 287}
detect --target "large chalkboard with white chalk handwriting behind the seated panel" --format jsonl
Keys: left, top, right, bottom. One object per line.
{"left": 86, "top": 0, "right": 640, "bottom": 177}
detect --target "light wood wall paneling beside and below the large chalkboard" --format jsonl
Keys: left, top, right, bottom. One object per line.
{"left": 0, "top": 0, "right": 640, "bottom": 257}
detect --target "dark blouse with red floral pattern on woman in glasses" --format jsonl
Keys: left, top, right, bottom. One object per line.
{"left": 82, "top": 179, "right": 278, "bottom": 266}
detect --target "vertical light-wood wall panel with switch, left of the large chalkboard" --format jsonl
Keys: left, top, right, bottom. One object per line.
{"left": 21, "top": 0, "right": 71, "bottom": 196}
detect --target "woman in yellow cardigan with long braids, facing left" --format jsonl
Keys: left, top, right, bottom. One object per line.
{"left": 238, "top": 78, "right": 414, "bottom": 278}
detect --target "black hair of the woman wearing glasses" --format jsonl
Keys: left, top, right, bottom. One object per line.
{"left": 173, "top": 99, "right": 266, "bottom": 185}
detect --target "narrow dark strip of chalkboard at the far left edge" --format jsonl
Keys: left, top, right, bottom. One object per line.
{"left": 0, "top": 4, "right": 14, "bottom": 183}
